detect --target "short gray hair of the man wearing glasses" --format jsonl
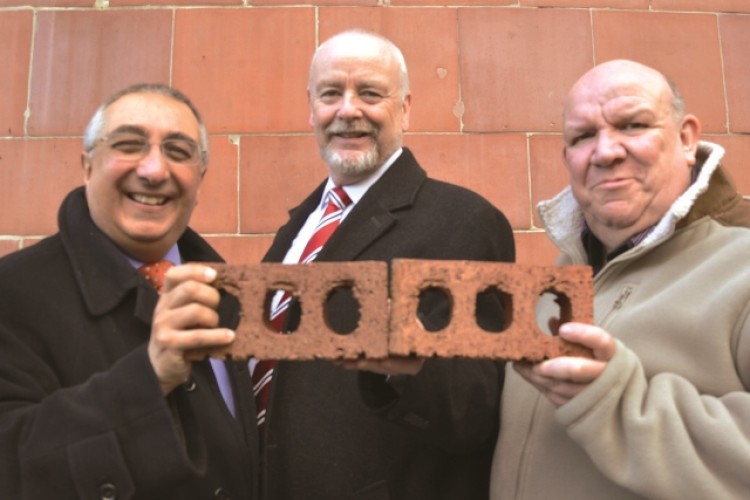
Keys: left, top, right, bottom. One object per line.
{"left": 83, "top": 83, "right": 209, "bottom": 168}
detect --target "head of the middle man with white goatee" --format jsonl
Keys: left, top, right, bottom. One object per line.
{"left": 308, "top": 37, "right": 411, "bottom": 184}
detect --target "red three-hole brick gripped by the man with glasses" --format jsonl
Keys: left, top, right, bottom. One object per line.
{"left": 214, "top": 262, "right": 388, "bottom": 359}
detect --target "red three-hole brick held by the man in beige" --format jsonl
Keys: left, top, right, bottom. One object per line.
{"left": 389, "top": 260, "right": 594, "bottom": 361}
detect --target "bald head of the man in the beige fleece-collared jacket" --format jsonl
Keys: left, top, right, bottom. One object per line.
{"left": 564, "top": 62, "right": 699, "bottom": 247}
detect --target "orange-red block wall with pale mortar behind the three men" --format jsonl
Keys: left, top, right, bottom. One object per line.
{"left": 0, "top": 0, "right": 750, "bottom": 264}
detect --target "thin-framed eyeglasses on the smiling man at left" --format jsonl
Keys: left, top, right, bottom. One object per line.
{"left": 99, "top": 133, "right": 202, "bottom": 166}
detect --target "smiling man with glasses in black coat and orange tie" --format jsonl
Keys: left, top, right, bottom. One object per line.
{"left": 0, "top": 85, "right": 255, "bottom": 500}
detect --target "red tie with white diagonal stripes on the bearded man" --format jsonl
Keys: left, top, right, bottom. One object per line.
{"left": 253, "top": 186, "right": 352, "bottom": 426}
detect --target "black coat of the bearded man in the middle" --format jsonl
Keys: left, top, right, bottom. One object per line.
{"left": 262, "top": 149, "right": 514, "bottom": 500}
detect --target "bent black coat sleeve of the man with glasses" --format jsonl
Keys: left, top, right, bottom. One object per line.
{"left": 0, "top": 342, "right": 203, "bottom": 500}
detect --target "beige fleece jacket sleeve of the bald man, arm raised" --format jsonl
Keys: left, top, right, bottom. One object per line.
{"left": 556, "top": 338, "right": 750, "bottom": 499}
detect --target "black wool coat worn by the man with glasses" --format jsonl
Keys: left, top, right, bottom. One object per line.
{"left": 0, "top": 188, "right": 257, "bottom": 500}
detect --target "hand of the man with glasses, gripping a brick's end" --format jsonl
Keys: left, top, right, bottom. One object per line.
{"left": 148, "top": 264, "right": 235, "bottom": 395}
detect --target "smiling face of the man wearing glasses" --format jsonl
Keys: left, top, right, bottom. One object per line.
{"left": 83, "top": 93, "right": 205, "bottom": 261}
